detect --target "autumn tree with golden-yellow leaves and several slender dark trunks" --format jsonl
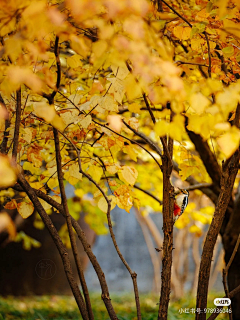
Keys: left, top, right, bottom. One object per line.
{"left": 0, "top": 0, "right": 240, "bottom": 320}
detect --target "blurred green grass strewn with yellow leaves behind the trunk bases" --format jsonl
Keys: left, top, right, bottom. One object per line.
{"left": 0, "top": 293, "right": 228, "bottom": 320}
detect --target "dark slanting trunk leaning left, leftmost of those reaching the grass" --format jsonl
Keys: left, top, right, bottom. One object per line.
{"left": 18, "top": 173, "right": 88, "bottom": 320}
